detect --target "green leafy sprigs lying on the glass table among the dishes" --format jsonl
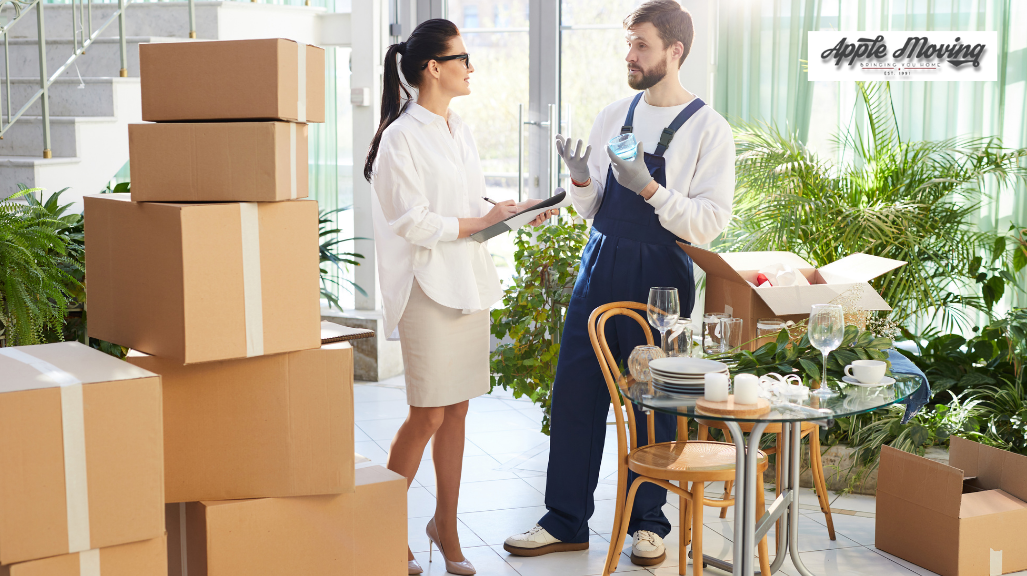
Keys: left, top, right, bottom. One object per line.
{"left": 713, "top": 325, "right": 893, "bottom": 382}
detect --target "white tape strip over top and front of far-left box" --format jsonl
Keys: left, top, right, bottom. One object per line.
{"left": 0, "top": 348, "right": 92, "bottom": 554}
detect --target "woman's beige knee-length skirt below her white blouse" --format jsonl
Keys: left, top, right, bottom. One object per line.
{"left": 400, "top": 280, "right": 490, "bottom": 408}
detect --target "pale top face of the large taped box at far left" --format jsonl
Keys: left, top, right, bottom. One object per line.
{"left": 0, "top": 342, "right": 157, "bottom": 393}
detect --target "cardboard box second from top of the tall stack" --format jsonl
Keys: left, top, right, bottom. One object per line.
{"left": 128, "top": 122, "right": 307, "bottom": 202}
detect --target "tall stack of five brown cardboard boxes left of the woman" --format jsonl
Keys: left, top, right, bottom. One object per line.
{"left": 85, "top": 39, "right": 407, "bottom": 576}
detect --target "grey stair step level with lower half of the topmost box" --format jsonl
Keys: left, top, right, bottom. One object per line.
{"left": 3, "top": 77, "right": 140, "bottom": 117}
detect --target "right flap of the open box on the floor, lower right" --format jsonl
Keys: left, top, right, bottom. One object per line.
{"left": 949, "top": 436, "right": 1027, "bottom": 501}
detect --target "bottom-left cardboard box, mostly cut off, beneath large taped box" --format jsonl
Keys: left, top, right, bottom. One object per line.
{"left": 0, "top": 534, "right": 167, "bottom": 576}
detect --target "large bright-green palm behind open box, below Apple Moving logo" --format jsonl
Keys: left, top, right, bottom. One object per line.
{"left": 723, "top": 82, "right": 1027, "bottom": 330}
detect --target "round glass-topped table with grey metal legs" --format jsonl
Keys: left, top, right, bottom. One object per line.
{"left": 621, "top": 374, "right": 920, "bottom": 576}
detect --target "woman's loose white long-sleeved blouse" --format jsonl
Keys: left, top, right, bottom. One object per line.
{"left": 372, "top": 102, "right": 502, "bottom": 340}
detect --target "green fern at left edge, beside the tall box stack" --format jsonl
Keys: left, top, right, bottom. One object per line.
{"left": 0, "top": 188, "right": 81, "bottom": 346}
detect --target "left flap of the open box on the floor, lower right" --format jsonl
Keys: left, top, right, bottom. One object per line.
{"left": 877, "top": 446, "right": 963, "bottom": 517}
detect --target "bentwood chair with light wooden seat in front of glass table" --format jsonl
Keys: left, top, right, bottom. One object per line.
{"left": 588, "top": 302, "right": 770, "bottom": 576}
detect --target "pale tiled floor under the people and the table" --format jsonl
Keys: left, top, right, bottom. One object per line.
{"left": 354, "top": 376, "right": 1010, "bottom": 576}
